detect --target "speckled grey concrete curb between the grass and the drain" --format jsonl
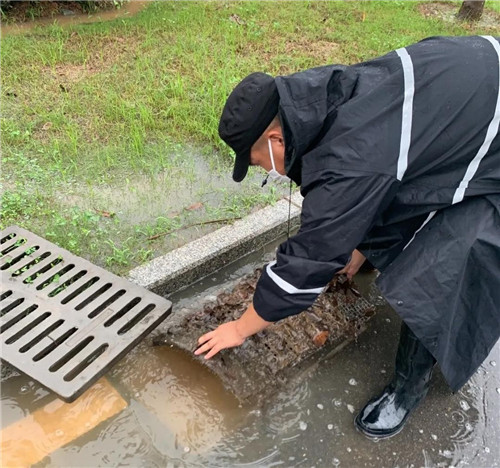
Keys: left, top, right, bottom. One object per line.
{"left": 128, "top": 192, "right": 302, "bottom": 296}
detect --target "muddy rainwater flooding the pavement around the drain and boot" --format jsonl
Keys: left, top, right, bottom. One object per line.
{"left": 1, "top": 241, "right": 500, "bottom": 468}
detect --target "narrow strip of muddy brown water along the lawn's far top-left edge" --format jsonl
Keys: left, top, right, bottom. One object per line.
{"left": 1, "top": 0, "right": 149, "bottom": 37}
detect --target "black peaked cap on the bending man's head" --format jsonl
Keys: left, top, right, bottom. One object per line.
{"left": 219, "top": 72, "right": 279, "bottom": 182}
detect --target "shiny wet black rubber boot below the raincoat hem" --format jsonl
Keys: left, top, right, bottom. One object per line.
{"left": 354, "top": 322, "right": 436, "bottom": 439}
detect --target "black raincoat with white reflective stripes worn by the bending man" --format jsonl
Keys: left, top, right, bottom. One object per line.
{"left": 254, "top": 36, "right": 500, "bottom": 391}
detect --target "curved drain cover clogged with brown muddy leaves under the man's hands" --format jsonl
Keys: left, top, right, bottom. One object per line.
{"left": 153, "top": 269, "right": 375, "bottom": 404}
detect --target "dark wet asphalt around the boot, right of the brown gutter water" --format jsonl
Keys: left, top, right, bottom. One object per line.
{"left": 167, "top": 266, "right": 500, "bottom": 468}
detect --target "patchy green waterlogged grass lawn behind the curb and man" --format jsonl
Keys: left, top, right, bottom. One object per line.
{"left": 1, "top": 1, "right": 500, "bottom": 274}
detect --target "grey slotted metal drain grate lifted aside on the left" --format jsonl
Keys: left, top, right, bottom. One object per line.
{"left": 0, "top": 226, "right": 172, "bottom": 402}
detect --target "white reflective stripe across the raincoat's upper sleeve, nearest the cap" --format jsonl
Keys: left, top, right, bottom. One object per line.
{"left": 396, "top": 47, "right": 415, "bottom": 180}
